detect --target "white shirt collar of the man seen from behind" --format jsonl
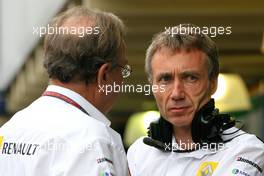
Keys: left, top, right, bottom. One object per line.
{"left": 46, "top": 85, "right": 111, "bottom": 126}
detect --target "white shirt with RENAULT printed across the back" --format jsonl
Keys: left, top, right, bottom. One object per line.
{"left": 0, "top": 85, "right": 128, "bottom": 176}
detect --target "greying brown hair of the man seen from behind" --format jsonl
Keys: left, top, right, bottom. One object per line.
{"left": 44, "top": 6, "right": 125, "bottom": 84}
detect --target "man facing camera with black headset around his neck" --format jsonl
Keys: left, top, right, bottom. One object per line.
{"left": 128, "top": 25, "right": 264, "bottom": 176}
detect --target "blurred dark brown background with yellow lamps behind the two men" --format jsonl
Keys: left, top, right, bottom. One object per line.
{"left": 0, "top": 0, "right": 264, "bottom": 147}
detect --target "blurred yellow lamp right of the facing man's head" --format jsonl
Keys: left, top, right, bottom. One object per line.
{"left": 212, "top": 74, "right": 251, "bottom": 112}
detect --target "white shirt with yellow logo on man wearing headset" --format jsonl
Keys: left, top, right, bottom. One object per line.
{"left": 128, "top": 128, "right": 264, "bottom": 176}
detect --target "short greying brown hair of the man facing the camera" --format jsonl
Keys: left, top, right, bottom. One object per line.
{"left": 145, "top": 24, "right": 219, "bottom": 81}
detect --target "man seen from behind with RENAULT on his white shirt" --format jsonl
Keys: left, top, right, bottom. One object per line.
{"left": 0, "top": 7, "right": 131, "bottom": 176}
